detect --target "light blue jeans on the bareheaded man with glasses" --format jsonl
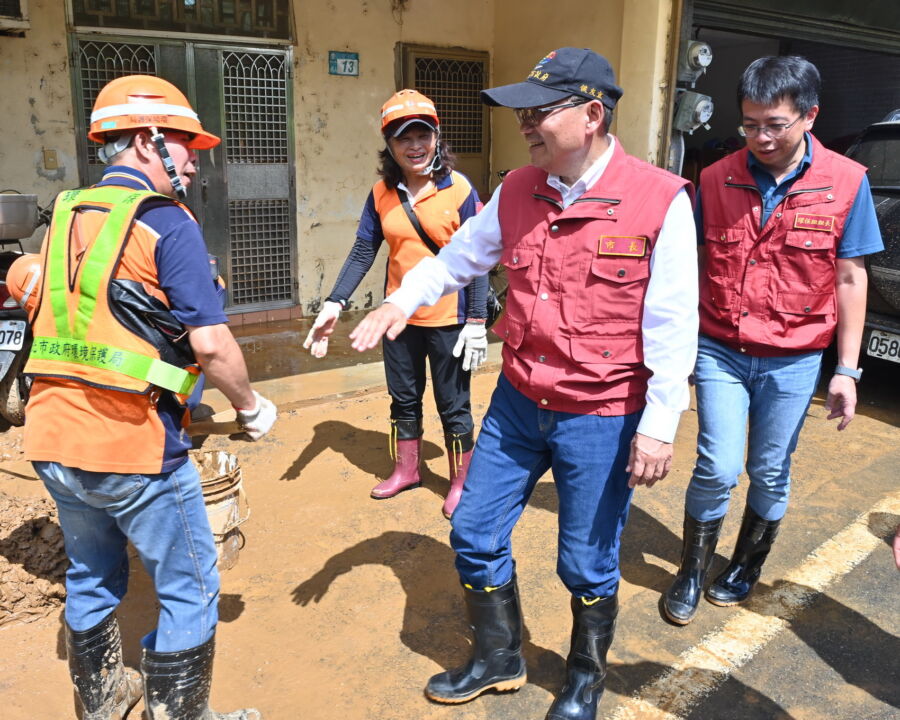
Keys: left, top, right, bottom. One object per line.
{"left": 685, "top": 335, "right": 822, "bottom": 522}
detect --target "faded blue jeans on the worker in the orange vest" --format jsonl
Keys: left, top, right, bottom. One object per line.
{"left": 34, "top": 462, "right": 219, "bottom": 652}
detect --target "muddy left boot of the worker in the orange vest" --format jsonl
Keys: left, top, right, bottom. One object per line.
{"left": 66, "top": 613, "right": 141, "bottom": 720}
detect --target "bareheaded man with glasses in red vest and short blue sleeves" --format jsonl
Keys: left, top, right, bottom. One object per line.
{"left": 663, "top": 57, "right": 883, "bottom": 625}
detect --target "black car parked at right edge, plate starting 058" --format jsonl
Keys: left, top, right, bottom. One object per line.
{"left": 847, "top": 109, "right": 900, "bottom": 372}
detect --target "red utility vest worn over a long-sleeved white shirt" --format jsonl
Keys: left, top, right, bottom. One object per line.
{"left": 494, "top": 142, "right": 693, "bottom": 415}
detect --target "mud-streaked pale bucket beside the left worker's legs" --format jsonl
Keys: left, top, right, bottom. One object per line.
{"left": 191, "top": 450, "right": 250, "bottom": 570}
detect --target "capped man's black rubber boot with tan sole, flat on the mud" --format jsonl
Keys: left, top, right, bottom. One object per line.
{"left": 425, "top": 575, "right": 527, "bottom": 703}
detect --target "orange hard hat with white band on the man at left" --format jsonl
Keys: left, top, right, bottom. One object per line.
{"left": 88, "top": 75, "right": 221, "bottom": 150}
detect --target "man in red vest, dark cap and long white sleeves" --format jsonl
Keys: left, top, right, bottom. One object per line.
{"left": 351, "top": 48, "right": 697, "bottom": 720}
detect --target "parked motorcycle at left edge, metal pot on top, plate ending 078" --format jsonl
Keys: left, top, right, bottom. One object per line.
{"left": 0, "top": 190, "right": 49, "bottom": 426}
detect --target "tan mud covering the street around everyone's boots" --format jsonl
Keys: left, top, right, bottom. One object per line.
{"left": 0, "top": 360, "right": 900, "bottom": 720}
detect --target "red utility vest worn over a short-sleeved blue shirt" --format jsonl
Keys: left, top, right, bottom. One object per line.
{"left": 700, "top": 138, "right": 866, "bottom": 357}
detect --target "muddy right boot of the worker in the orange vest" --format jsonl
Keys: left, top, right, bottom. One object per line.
{"left": 141, "top": 637, "right": 262, "bottom": 720}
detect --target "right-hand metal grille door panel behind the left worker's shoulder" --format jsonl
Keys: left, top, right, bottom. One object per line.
{"left": 194, "top": 45, "right": 296, "bottom": 311}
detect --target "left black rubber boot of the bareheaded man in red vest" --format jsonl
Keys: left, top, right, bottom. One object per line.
{"left": 663, "top": 512, "right": 723, "bottom": 625}
